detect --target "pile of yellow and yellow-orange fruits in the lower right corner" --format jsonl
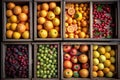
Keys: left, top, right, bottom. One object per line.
{"left": 92, "top": 45, "right": 115, "bottom": 78}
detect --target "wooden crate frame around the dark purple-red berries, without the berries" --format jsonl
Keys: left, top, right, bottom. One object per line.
{"left": 1, "top": 42, "right": 32, "bottom": 80}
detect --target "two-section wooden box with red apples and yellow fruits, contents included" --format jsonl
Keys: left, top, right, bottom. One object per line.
{"left": 61, "top": 42, "right": 120, "bottom": 80}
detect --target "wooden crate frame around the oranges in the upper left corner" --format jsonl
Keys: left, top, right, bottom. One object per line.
{"left": 2, "top": 0, "right": 33, "bottom": 41}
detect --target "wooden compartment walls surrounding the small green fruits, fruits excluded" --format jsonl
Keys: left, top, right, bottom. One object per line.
{"left": 32, "top": 42, "right": 61, "bottom": 80}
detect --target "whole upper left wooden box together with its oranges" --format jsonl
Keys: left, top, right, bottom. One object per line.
{"left": 2, "top": 0, "right": 33, "bottom": 41}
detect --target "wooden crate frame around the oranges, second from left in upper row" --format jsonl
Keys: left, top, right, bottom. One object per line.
{"left": 34, "top": 0, "right": 63, "bottom": 41}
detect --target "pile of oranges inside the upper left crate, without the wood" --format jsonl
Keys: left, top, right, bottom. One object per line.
{"left": 6, "top": 2, "right": 29, "bottom": 39}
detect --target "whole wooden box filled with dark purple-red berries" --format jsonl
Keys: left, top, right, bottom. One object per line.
{"left": 1, "top": 42, "right": 32, "bottom": 80}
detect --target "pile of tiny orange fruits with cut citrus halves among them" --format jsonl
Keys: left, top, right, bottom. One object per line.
{"left": 65, "top": 3, "right": 90, "bottom": 38}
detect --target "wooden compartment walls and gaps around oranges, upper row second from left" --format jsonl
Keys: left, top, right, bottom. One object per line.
{"left": 34, "top": 0, "right": 63, "bottom": 41}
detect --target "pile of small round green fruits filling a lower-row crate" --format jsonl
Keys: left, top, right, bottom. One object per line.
{"left": 36, "top": 44, "right": 58, "bottom": 79}
